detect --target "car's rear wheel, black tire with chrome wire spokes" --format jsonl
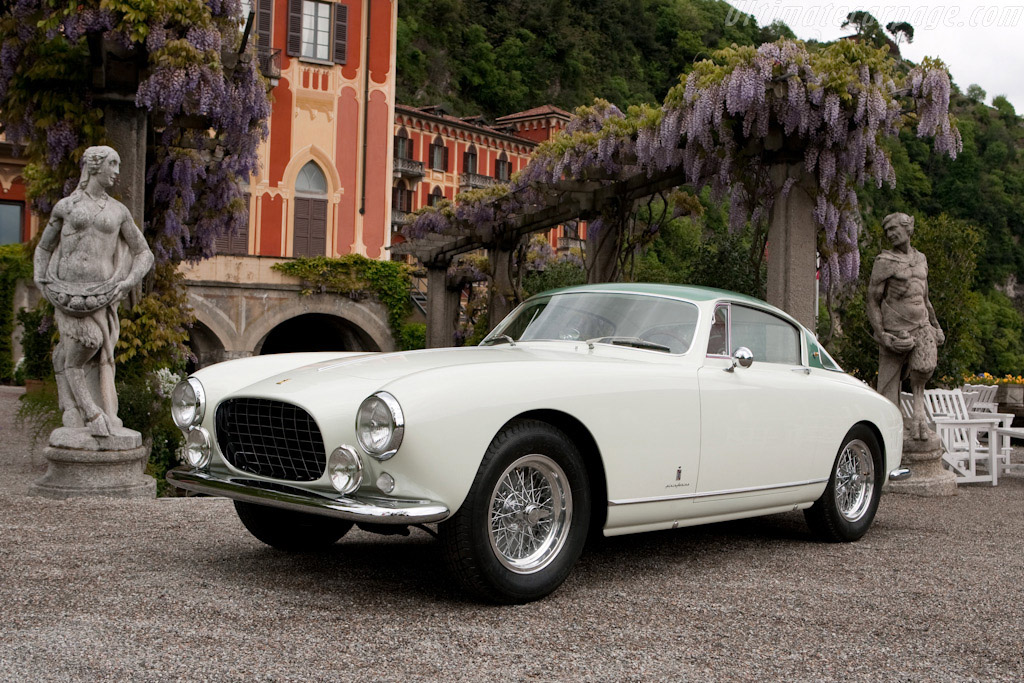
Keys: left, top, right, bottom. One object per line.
{"left": 804, "top": 425, "right": 885, "bottom": 543}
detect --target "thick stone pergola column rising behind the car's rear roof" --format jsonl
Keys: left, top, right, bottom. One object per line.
{"left": 767, "top": 164, "right": 818, "bottom": 332}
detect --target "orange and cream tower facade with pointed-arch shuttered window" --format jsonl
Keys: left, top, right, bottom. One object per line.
{"left": 226, "top": 0, "right": 398, "bottom": 258}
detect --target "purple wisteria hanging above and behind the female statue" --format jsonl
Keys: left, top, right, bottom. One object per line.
{"left": 0, "top": 0, "right": 270, "bottom": 262}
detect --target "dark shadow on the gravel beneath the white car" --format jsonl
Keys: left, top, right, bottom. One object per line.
{"left": 161, "top": 513, "right": 815, "bottom": 604}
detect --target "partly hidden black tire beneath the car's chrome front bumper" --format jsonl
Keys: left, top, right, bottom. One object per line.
{"left": 234, "top": 501, "right": 352, "bottom": 553}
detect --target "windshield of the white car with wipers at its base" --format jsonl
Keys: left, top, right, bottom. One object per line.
{"left": 480, "top": 292, "right": 697, "bottom": 353}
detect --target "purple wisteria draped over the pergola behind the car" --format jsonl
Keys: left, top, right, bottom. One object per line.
{"left": 406, "top": 40, "right": 962, "bottom": 294}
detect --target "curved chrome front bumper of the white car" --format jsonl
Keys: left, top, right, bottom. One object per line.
{"left": 167, "top": 467, "right": 450, "bottom": 524}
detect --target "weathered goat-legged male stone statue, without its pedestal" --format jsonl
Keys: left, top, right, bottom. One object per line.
{"left": 867, "top": 213, "right": 946, "bottom": 439}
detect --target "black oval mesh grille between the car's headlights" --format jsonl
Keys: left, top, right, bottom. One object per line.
{"left": 217, "top": 398, "right": 327, "bottom": 481}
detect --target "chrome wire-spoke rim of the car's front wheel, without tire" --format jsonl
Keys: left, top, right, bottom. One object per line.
{"left": 487, "top": 454, "right": 572, "bottom": 573}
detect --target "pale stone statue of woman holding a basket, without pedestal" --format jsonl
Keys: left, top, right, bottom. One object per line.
{"left": 35, "top": 146, "right": 154, "bottom": 437}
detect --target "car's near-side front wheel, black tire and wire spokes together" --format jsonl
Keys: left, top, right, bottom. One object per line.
{"left": 438, "top": 420, "right": 591, "bottom": 603}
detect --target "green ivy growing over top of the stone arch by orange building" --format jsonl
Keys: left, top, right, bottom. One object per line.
{"left": 272, "top": 254, "right": 414, "bottom": 343}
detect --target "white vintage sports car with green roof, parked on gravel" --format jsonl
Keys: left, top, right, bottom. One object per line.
{"left": 168, "top": 285, "right": 908, "bottom": 602}
